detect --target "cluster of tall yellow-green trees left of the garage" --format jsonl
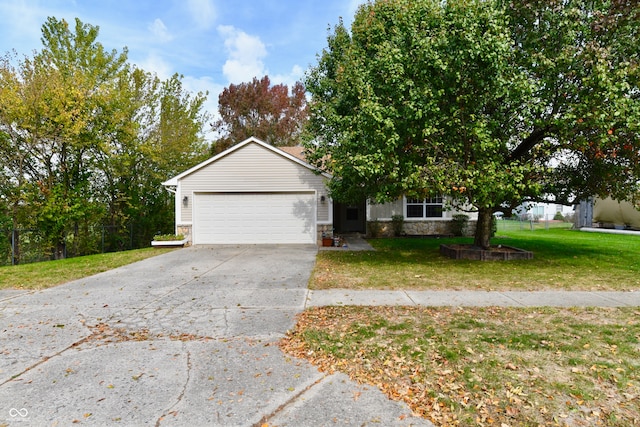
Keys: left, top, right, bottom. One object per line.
{"left": 0, "top": 18, "right": 208, "bottom": 262}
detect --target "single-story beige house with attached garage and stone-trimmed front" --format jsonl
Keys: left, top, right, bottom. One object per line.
{"left": 163, "top": 137, "right": 475, "bottom": 245}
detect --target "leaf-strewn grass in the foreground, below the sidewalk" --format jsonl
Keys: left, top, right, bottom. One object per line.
{"left": 281, "top": 307, "right": 640, "bottom": 427}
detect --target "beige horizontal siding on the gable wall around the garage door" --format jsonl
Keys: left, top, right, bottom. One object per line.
{"left": 176, "top": 143, "right": 329, "bottom": 223}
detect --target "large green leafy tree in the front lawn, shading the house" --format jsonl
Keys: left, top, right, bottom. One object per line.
{"left": 305, "top": 0, "right": 640, "bottom": 248}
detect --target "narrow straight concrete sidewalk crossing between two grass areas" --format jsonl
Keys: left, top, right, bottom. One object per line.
{"left": 305, "top": 289, "right": 640, "bottom": 307}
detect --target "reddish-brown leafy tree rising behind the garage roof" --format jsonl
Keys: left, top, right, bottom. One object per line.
{"left": 212, "top": 76, "right": 308, "bottom": 152}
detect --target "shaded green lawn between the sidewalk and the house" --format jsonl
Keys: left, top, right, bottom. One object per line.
{"left": 310, "top": 226, "right": 640, "bottom": 291}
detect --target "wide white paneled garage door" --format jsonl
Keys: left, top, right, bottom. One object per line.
{"left": 193, "top": 193, "right": 316, "bottom": 244}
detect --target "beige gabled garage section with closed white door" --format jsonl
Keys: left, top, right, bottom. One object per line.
{"left": 163, "top": 138, "right": 333, "bottom": 245}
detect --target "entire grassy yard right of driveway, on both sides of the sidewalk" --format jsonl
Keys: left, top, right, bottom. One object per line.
{"left": 281, "top": 226, "right": 640, "bottom": 427}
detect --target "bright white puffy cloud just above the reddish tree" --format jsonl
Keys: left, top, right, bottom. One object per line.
{"left": 218, "top": 25, "right": 267, "bottom": 84}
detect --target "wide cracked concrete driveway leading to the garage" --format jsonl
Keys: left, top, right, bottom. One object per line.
{"left": 0, "top": 245, "right": 431, "bottom": 426}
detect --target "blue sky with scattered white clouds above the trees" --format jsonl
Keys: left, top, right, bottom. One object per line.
{"left": 0, "top": 0, "right": 364, "bottom": 120}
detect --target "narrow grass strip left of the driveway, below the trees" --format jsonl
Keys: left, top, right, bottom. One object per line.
{"left": 0, "top": 248, "right": 172, "bottom": 289}
